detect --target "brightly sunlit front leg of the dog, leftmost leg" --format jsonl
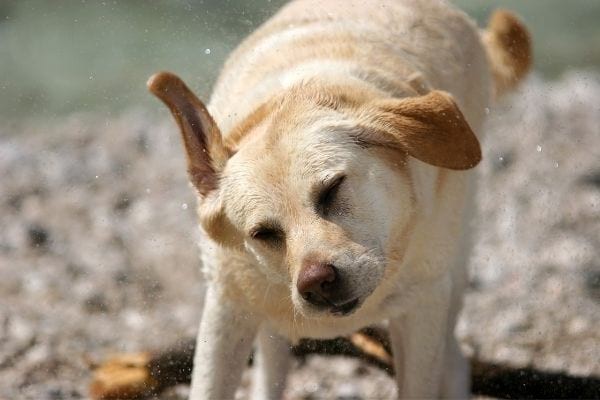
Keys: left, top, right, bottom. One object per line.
{"left": 190, "top": 287, "right": 259, "bottom": 400}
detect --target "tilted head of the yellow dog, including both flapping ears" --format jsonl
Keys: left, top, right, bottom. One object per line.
{"left": 148, "top": 73, "right": 481, "bottom": 317}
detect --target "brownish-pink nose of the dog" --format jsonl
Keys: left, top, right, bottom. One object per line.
{"left": 296, "top": 263, "right": 337, "bottom": 306}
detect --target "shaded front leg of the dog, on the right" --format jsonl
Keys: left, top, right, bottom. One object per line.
{"left": 390, "top": 282, "right": 450, "bottom": 399}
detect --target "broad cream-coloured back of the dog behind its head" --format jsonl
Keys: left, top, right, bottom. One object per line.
{"left": 209, "top": 0, "right": 491, "bottom": 135}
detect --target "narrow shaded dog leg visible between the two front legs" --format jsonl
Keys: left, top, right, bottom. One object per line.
{"left": 252, "top": 326, "right": 290, "bottom": 400}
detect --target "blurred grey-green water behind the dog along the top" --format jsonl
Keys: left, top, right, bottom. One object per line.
{"left": 0, "top": 0, "right": 600, "bottom": 122}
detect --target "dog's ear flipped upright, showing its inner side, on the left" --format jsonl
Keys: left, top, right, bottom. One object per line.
{"left": 147, "top": 72, "right": 230, "bottom": 196}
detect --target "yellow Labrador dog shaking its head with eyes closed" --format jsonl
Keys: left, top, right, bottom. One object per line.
{"left": 148, "top": 0, "right": 531, "bottom": 400}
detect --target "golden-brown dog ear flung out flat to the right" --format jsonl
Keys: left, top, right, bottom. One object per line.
{"left": 358, "top": 90, "right": 481, "bottom": 170}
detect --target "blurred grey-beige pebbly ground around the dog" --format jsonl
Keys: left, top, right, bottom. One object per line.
{"left": 0, "top": 72, "right": 600, "bottom": 399}
